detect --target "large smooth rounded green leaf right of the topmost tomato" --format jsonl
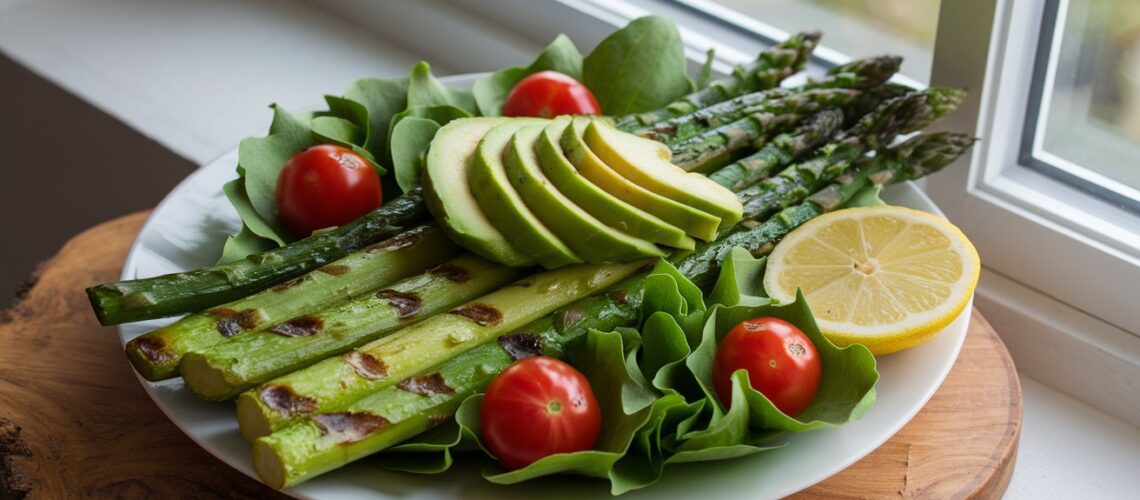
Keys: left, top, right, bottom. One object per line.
{"left": 581, "top": 16, "right": 693, "bottom": 116}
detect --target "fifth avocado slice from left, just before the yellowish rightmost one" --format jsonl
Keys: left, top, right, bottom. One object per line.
{"left": 560, "top": 116, "right": 720, "bottom": 241}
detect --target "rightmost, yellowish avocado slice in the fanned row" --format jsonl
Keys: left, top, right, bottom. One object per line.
{"left": 583, "top": 120, "right": 744, "bottom": 229}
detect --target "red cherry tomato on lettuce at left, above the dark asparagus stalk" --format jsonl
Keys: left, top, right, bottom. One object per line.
{"left": 277, "top": 145, "right": 381, "bottom": 236}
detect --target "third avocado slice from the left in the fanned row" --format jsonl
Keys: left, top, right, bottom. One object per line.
{"left": 503, "top": 124, "right": 666, "bottom": 262}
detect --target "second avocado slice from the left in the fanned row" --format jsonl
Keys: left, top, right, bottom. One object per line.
{"left": 467, "top": 118, "right": 584, "bottom": 269}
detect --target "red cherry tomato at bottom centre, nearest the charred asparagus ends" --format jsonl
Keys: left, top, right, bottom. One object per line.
{"left": 480, "top": 356, "right": 602, "bottom": 469}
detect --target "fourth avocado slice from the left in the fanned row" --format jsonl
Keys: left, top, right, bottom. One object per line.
{"left": 535, "top": 116, "right": 695, "bottom": 249}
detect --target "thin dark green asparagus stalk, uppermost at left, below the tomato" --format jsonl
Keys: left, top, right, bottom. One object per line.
{"left": 87, "top": 189, "right": 428, "bottom": 325}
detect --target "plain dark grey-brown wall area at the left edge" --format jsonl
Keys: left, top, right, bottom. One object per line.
{"left": 0, "top": 55, "right": 195, "bottom": 302}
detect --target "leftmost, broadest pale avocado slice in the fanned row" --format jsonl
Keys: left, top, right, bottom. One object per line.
{"left": 423, "top": 117, "right": 535, "bottom": 267}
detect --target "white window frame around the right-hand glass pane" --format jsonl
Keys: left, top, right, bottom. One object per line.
{"left": 927, "top": 0, "right": 1140, "bottom": 338}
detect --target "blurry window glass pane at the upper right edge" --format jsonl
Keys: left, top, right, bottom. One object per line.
{"left": 1029, "top": 0, "right": 1140, "bottom": 208}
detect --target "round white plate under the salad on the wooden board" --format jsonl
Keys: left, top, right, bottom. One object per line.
{"left": 119, "top": 76, "right": 971, "bottom": 499}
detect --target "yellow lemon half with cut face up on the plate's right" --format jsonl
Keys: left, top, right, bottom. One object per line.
{"left": 764, "top": 206, "right": 982, "bottom": 355}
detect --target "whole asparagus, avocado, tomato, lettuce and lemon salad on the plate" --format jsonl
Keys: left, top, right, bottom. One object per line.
{"left": 88, "top": 16, "right": 979, "bottom": 494}
